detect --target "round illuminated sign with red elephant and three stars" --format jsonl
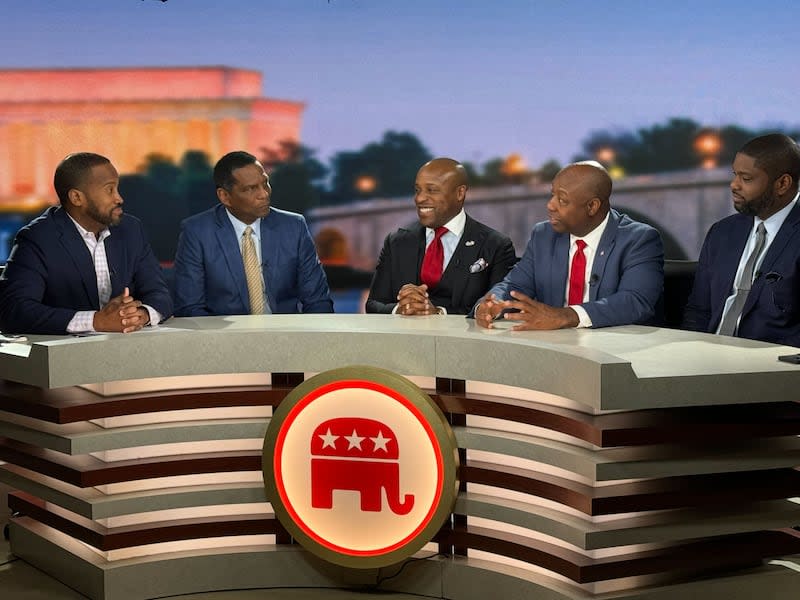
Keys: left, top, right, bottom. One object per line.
{"left": 263, "top": 367, "right": 458, "bottom": 568}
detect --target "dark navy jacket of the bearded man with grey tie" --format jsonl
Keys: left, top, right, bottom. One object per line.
{"left": 683, "top": 204, "right": 800, "bottom": 347}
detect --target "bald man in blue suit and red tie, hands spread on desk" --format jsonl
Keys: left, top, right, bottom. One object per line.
{"left": 475, "top": 161, "right": 664, "bottom": 330}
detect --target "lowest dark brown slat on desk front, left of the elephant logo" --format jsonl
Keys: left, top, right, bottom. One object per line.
{"left": 8, "top": 492, "right": 278, "bottom": 550}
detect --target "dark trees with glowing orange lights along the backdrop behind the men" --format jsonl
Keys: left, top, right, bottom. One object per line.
{"left": 120, "top": 117, "right": 800, "bottom": 261}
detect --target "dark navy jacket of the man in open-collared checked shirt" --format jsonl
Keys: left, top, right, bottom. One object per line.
{"left": 0, "top": 206, "right": 172, "bottom": 334}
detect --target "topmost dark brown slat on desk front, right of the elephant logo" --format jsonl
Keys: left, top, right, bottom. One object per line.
{"left": 433, "top": 393, "right": 800, "bottom": 448}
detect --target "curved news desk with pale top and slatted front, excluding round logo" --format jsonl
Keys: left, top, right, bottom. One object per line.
{"left": 0, "top": 315, "right": 800, "bottom": 600}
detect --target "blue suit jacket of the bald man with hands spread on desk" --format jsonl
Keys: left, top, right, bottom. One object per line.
{"left": 491, "top": 209, "right": 664, "bottom": 327}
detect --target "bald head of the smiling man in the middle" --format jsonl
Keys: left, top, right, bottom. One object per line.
{"left": 414, "top": 158, "right": 467, "bottom": 229}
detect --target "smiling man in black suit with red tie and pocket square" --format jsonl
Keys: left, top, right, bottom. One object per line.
{"left": 366, "top": 158, "right": 516, "bottom": 316}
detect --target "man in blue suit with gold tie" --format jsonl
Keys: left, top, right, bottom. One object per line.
{"left": 175, "top": 151, "right": 333, "bottom": 316}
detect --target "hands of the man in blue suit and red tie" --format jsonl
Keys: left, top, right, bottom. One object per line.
{"left": 475, "top": 291, "right": 578, "bottom": 331}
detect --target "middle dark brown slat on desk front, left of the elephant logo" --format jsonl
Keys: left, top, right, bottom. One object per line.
{"left": 0, "top": 438, "right": 261, "bottom": 487}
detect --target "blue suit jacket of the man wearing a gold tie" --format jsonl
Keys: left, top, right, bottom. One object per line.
{"left": 175, "top": 204, "right": 333, "bottom": 317}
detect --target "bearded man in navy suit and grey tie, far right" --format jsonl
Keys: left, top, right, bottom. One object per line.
{"left": 683, "top": 134, "right": 800, "bottom": 347}
